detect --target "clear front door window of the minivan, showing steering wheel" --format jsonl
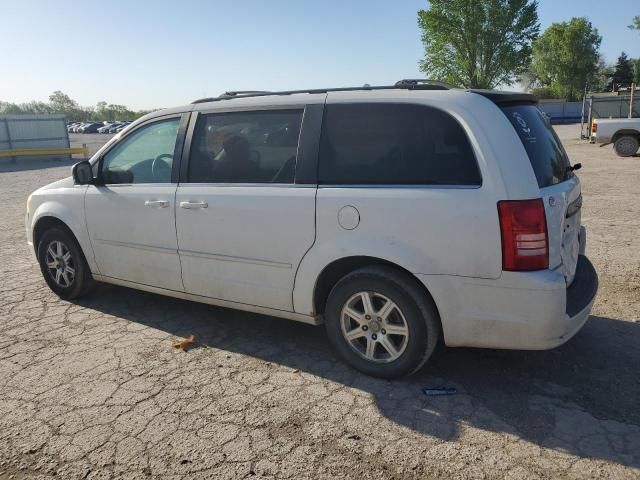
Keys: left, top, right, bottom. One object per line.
{"left": 102, "top": 118, "right": 180, "bottom": 184}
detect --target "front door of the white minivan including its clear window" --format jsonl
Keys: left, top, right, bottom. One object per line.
{"left": 85, "top": 116, "right": 183, "bottom": 291}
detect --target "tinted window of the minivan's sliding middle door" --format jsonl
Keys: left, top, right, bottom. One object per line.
{"left": 188, "top": 111, "right": 302, "bottom": 183}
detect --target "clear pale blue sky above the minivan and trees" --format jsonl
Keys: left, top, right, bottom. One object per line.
{"left": 0, "top": 0, "right": 640, "bottom": 109}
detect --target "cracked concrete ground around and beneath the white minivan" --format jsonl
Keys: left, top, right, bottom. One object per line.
{"left": 0, "top": 126, "right": 640, "bottom": 480}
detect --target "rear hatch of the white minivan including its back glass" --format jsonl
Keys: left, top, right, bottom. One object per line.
{"left": 501, "top": 103, "right": 582, "bottom": 285}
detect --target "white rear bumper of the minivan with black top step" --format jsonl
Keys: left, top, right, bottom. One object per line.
{"left": 419, "top": 255, "right": 598, "bottom": 350}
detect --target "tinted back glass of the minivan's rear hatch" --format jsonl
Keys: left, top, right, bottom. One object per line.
{"left": 502, "top": 105, "right": 573, "bottom": 188}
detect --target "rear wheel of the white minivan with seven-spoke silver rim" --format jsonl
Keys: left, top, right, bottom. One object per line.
{"left": 325, "top": 266, "right": 440, "bottom": 379}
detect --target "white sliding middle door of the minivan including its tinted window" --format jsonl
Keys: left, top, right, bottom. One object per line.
{"left": 176, "top": 108, "right": 316, "bottom": 310}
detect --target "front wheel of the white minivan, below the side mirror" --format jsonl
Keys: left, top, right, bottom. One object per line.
{"left": 38, "top": 227, "right": 95, "bottom": 300}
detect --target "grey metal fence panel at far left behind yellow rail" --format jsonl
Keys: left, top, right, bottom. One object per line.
{"left": 0, "top": 115, "right": 70, "bottom": 163}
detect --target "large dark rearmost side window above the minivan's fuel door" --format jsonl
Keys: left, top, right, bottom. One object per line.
{"left": 318, "top": 103, "right": 482, "bottom": 185}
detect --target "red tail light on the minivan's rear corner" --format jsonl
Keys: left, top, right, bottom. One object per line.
{"left": 498, "top": 198, "right": 549, "bottom": 271}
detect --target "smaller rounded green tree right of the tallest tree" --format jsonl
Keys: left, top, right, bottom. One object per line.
{"left": 532, "top": 17, "right": 602, "bottom": 101}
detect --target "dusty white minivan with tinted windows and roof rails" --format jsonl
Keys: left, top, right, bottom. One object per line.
{"left": 26, "top": 80, "right": 598, "bottom": 378}
